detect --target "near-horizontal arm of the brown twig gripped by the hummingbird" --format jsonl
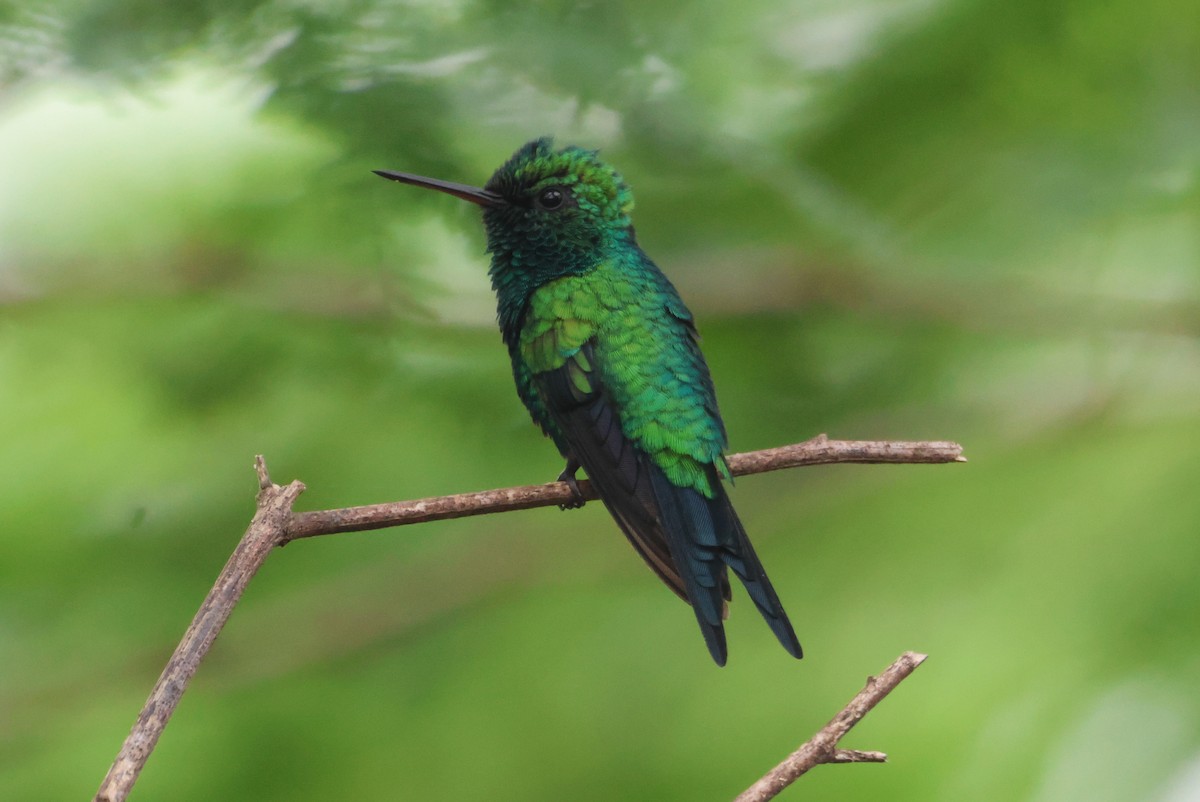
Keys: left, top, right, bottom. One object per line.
{"left": 288, "top": 435, "right": 966, "bottom": 540}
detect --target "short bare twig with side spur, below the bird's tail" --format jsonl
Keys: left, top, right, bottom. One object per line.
{"left": 733, "top": 652, "right": 925, "bottom": 802}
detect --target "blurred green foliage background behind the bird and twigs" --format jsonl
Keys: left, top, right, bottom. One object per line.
{"left": 0, "top": 0, "right": 1200, "bottom": 802}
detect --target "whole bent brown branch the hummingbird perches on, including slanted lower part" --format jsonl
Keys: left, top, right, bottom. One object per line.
{"left": 94, "top": 435, "right": 966, "bottom": 802}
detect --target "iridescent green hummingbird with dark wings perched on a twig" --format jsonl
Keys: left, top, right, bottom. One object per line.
{"left": 374, "top": 137, "right": 802, "bottom": 665}
